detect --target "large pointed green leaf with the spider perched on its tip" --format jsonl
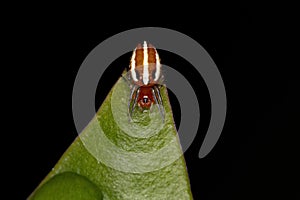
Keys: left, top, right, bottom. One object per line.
{"left": 29, "top": 78, "right": 193, "bottom": 200}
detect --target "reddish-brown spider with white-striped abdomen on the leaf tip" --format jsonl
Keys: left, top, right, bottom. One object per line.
{"left": 128, "top": 41, "right": 164, "bottom": 119}
